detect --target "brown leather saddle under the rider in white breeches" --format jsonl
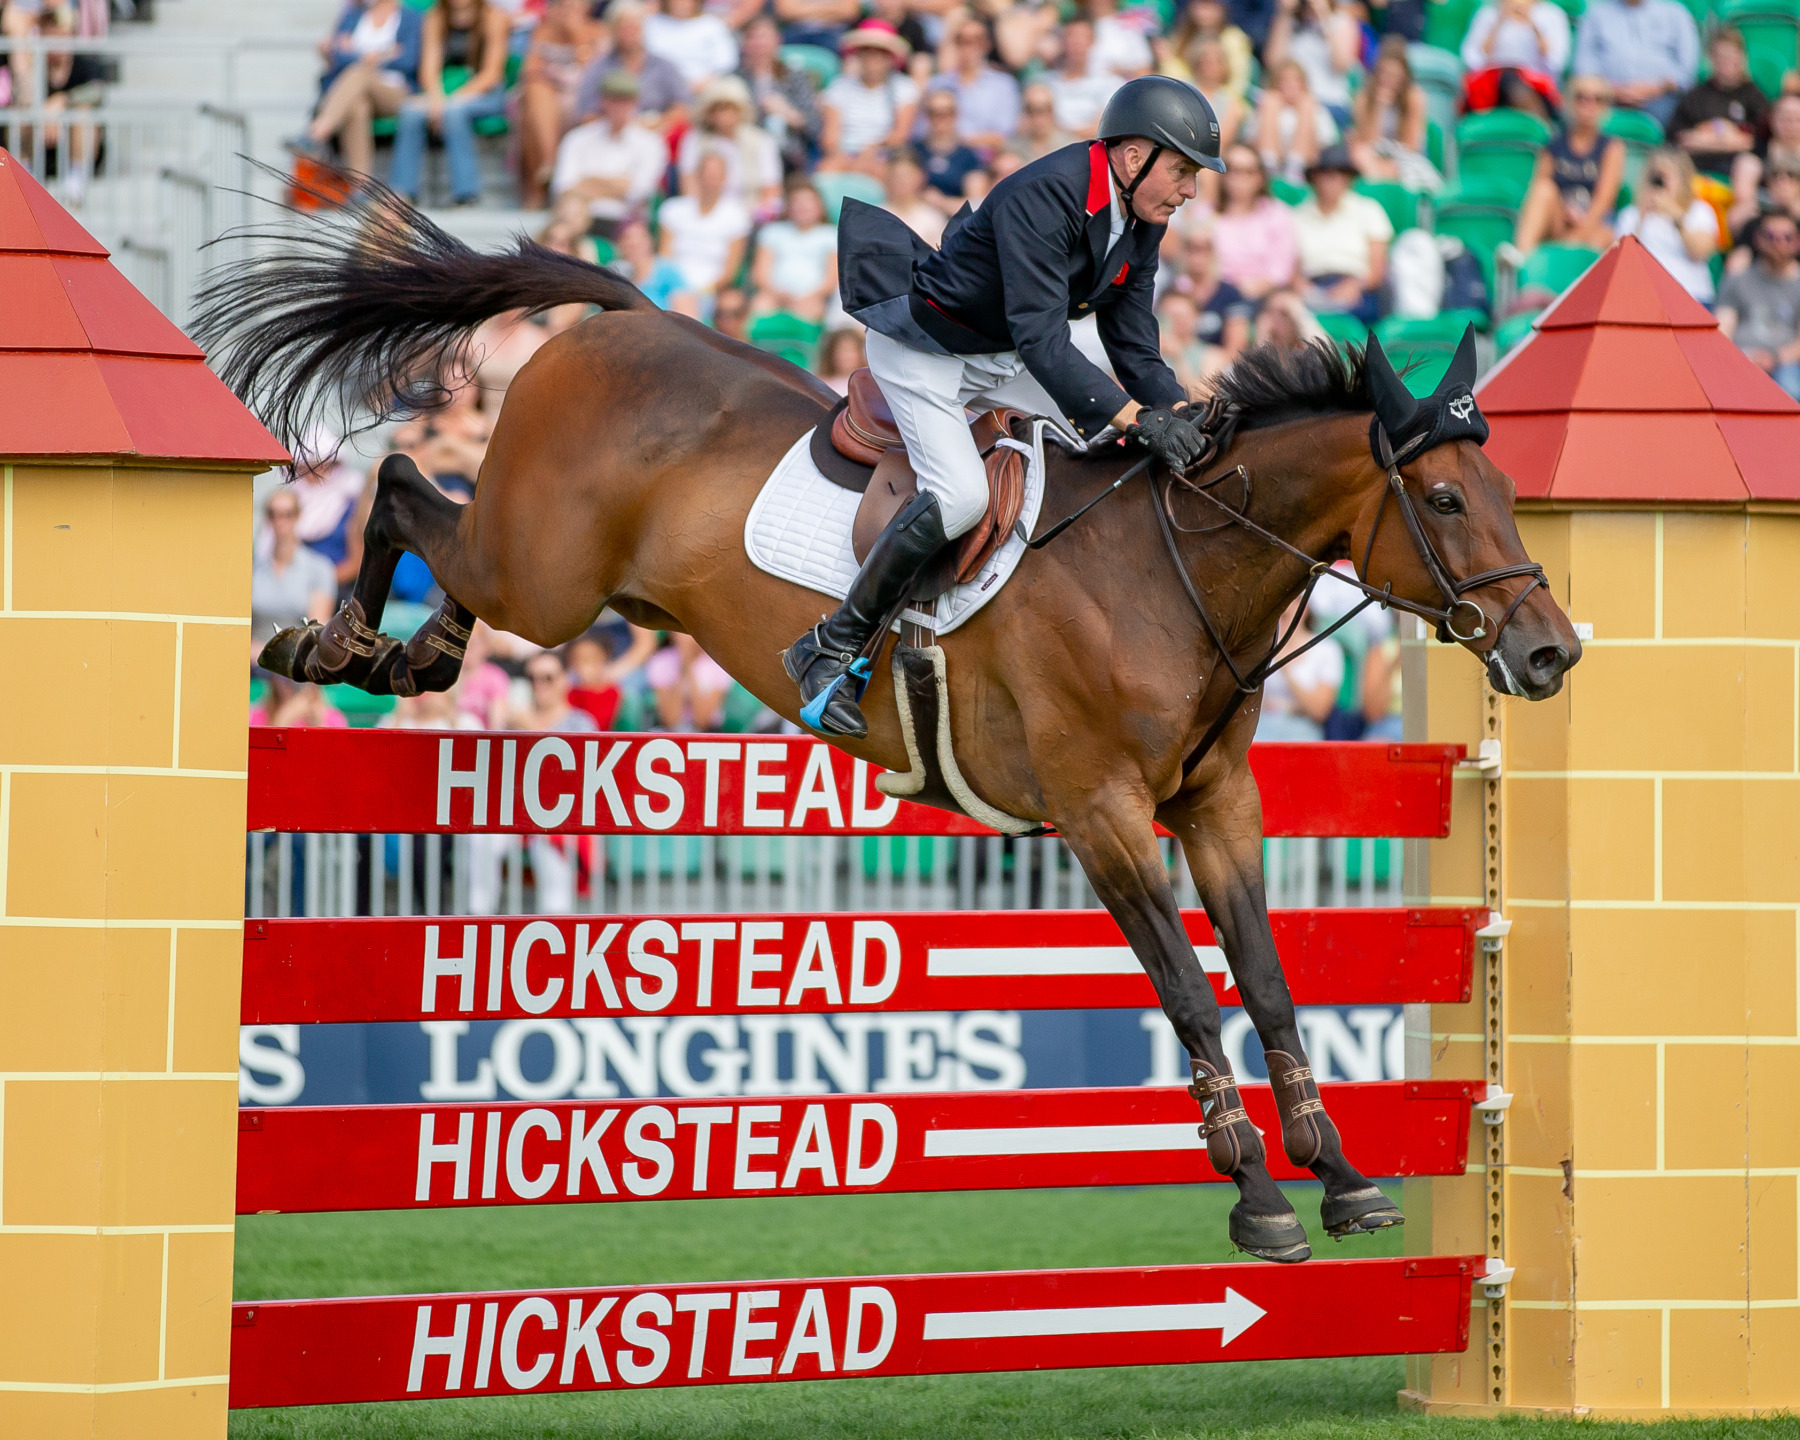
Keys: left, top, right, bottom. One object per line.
{"left": 812, "top": 369, "right": 1028, "bottom": 599}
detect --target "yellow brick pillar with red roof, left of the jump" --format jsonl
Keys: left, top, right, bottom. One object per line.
{"left": 0, "top": 151, "right": 281, "bottom": 1440}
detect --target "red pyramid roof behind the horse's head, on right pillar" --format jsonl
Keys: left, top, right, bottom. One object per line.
{"left": 1476, "top": 236, "right": 1800, "bottom": 504}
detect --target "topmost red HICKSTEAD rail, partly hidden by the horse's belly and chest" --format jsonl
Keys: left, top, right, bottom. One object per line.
{"left": 248, "top": 727, "right": 1463, "bottom": 837}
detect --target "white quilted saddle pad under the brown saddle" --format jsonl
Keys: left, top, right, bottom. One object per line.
{"left": 743, "top": 419, "right": 1049, "bottom": 635}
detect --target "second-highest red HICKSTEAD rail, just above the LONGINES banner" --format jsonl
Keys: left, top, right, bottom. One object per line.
{"left": 241, "top": 907, "right": 1487, "bottom": 1024}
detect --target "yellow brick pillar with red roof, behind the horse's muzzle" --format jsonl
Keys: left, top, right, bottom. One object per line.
{"left": 1402, "top": 241, "right": 1800, "bottom": 1420}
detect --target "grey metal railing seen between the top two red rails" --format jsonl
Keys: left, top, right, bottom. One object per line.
{"left": 245, "top": 833, "right": 1402, "bottom": 918}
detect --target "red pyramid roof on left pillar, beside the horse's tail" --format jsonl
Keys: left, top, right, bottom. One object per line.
{"left": 0, "top": 149, "right": 288, "bottom": 464}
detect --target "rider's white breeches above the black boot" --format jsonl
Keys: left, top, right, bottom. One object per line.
{"left": 864, "top": 329, "right": 1062, "bottom": 540}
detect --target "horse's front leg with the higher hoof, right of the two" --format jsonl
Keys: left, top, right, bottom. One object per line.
{"left": 1157, "top": 752, "right": 1406, "bottom": 1237}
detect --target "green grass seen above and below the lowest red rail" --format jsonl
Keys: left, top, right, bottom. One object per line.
{"left": 230, "top": 1184, "right": 1800, "bottom": 1440}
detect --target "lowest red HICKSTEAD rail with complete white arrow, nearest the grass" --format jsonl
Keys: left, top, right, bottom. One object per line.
{"left": 230, "top": 1255, "right": 1481, "bottom": 1409}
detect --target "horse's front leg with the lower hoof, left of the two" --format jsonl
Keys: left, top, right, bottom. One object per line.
{"left": 1048, "top": 779, "right": 1312, "bottom": 1262}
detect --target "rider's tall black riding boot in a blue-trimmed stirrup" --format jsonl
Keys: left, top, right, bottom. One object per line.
{"left": 781, "top": 493, "right": 949, "bottom": 740}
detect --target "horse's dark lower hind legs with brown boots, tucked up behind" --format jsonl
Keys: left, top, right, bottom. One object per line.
{"left": 261, "top": 455, "right": 475, "bottom": 695}
